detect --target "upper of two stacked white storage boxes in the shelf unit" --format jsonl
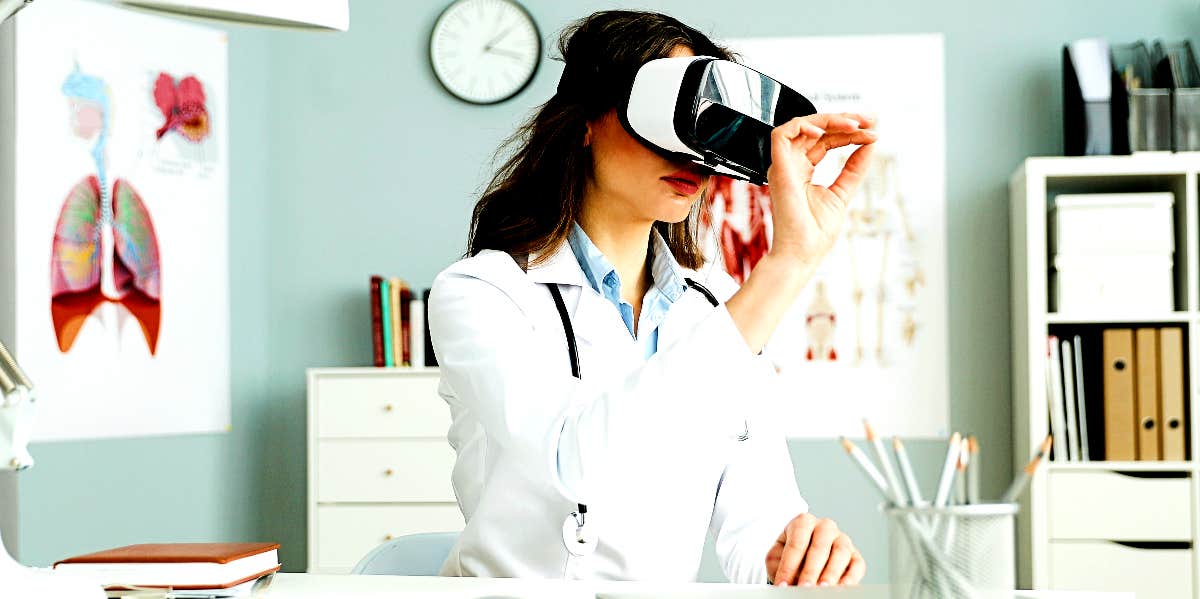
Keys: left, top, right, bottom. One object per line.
{"left": 1049, "top": 192, "right": 1175, "bottom": 256}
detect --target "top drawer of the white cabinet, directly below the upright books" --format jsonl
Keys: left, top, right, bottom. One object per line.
{"left": 314, "top": 372, "right": 450, "bottom": 438}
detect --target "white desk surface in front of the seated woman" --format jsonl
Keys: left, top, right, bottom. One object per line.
{"left": 263, "top": 574, "right": 1133, "bottom": 599}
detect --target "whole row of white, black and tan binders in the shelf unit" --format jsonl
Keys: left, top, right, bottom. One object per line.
{"left": 1046, "top": 327, "right": 1188, "bottom": 462}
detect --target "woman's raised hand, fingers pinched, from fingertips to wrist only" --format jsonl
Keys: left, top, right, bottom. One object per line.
{"left": 767, "top": 113, "right": 877, "bottom": 265}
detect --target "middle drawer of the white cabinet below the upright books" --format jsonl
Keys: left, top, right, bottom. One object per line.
{"left": 317, "top": 439, "right": 455, "bottom": 503}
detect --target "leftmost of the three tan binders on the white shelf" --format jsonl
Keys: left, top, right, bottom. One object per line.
{"left": 1103, "top": 329, "right": 1138, "bottom": 461}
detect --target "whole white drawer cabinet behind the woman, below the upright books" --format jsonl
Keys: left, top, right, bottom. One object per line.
{"left": 307, "top": 369, "right": 463, "bottom": 574}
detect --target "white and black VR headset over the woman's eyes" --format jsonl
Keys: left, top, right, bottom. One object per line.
{"left": 618, "top": 56, "right": 817, "bottom": 185}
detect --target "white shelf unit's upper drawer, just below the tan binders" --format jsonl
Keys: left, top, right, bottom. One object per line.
{"left": 1048, "top": 471, "right": 1192, "bottom": 541}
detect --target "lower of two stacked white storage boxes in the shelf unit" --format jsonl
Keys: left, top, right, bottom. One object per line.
{"left": 1050, "top": 253, "right": 1175, "bottom": 315}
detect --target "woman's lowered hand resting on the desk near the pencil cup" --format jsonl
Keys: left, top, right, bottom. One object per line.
{"left": 767, "top": 514, "right": 866, "bottom": 587}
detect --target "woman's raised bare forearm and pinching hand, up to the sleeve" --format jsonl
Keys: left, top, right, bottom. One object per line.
{"left": 726, "top": 113, "right": 876, "bottom": 353}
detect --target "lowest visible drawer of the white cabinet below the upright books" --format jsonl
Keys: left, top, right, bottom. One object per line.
{"left": 311, "top": 503, "right": 463, "bottom": 573}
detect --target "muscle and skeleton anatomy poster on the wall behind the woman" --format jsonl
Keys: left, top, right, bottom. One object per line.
{"left": 707, "top": 35, "right": 949, "bottom": 437}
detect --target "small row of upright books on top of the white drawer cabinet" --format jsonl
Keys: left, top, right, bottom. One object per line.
{"left": 371, "top": 275, "right": 438, "bottom": 367}
